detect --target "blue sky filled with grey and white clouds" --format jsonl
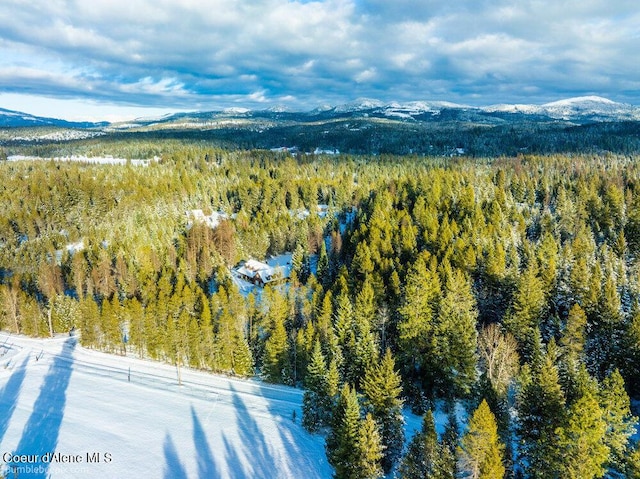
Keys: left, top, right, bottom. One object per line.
{"left": 0, "top": 0, "right": 640, "bottom": 121}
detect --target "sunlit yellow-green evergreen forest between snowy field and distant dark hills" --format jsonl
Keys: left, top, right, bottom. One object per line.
{"left": 0, "top": 147, "right": 640, "bottom": 479}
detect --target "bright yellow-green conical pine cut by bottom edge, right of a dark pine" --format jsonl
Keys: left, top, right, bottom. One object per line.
{"left": 460, "top": 399, "right": 505, "bottom": 479}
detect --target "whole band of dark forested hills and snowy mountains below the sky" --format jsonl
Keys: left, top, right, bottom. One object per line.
{"left": 0, "top": 96, "right": 640, "bottom": 157}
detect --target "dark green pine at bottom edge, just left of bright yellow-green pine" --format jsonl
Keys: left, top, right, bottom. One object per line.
{"left": 398, "top": 409, "right": 454, "bottom": 479}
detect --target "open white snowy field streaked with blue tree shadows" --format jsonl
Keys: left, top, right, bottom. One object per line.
{"left": 0, "top": 334, "right": 332, "bottom": 479}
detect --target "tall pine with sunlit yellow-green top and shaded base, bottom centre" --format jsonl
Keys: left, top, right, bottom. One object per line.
{"left": 362, "top": 349, "right": 404, "bottom": 473}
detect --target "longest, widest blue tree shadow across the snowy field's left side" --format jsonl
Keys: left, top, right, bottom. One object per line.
{"left": 8, "top": 338, "right": 76, "bottom": 479}
